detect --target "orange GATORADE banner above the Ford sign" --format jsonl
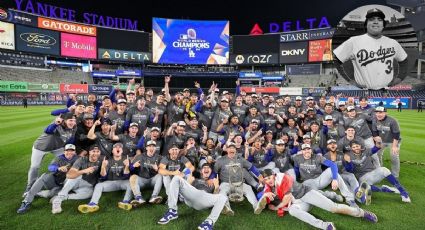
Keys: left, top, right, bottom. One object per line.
{"left": 38, "top": 17, "right": 96, "bottom": 36}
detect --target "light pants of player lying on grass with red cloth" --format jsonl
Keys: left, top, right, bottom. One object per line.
{"left": 288, "top": 190, "right": 364, "bottom": 229}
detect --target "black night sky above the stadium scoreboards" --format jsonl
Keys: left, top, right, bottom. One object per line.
{"left": 0, "top": 0, "right": 386, "bottom": 35}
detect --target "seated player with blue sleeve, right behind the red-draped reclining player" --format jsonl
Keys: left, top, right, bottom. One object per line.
{"left": 292, "top": 144, "right": 358, "bottom": 207}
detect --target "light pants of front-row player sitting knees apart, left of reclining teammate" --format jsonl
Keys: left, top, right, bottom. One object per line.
{"left": 129, "top": 174, "right": 162, "bottom": 197}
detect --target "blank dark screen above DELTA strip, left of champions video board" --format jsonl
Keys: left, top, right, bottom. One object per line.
{"left": 97, "top": 27, "right": 150, "bottom": 53}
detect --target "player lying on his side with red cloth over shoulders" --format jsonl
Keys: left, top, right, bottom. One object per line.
{"left": 255, "top": 169, "right": 378, "bottom": 229}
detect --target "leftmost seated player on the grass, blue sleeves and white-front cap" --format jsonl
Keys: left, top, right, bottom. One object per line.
{"left": 17, "top": 144, "right": 78, "bottom": 214}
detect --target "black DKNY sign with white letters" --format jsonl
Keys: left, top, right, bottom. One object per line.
{"left": 280, "top": 42, "right": 308, "bottom": 64}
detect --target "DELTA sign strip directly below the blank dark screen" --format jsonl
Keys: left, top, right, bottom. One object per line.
{"left": 98, "top": 48, "right": 152, "bottom": 62}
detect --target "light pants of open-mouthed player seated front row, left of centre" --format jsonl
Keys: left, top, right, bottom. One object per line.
{"left": 90, "top": 180, "right": 132, "bottom": 204}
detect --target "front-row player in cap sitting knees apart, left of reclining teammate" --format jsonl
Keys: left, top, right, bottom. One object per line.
{"left": 130, "top": 141, "right": 162, "bottom": 207}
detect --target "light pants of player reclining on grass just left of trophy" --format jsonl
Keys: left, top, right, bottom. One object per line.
{"left": 168, "top": 176, "right": 227, "bottom": 223}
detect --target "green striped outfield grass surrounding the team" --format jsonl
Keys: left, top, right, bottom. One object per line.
{"left": 0, "top": 106, "right": 425, "bottom": 230}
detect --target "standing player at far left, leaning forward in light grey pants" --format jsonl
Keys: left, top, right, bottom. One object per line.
{"left": 23, "top": 113, "right": 77, "bottom": 197}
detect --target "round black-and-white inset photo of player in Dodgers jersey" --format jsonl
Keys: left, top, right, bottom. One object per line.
{"left": 333, "top": 5, "right": 423, "bottom": 90}
